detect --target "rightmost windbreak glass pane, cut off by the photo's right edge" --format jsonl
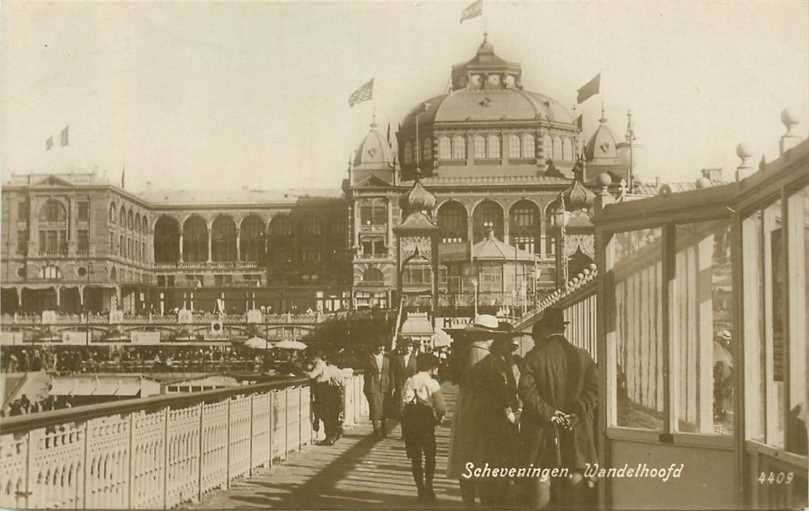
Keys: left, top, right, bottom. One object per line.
{"left": 786, "top": 185, "right": 809, "bottom": 458}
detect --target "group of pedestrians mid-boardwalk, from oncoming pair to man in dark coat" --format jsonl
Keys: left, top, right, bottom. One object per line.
{"left": 356, "top": 308, "right": 598, "bottom": 509}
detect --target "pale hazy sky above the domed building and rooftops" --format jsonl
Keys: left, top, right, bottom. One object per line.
{"left": 0, "top": 0, "right": 809, "bottom": 191}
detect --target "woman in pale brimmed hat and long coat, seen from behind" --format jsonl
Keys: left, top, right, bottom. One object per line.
{"left": 447, "top": 314, "right": 505, "bottom": 507}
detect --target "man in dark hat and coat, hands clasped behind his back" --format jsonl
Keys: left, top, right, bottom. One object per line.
{"left": 519, "top": 308, "right": 598, "bottom": 508}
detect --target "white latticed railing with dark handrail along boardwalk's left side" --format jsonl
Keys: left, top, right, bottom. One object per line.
{"left": 0, "top": 375, "right": 368, "bottom": 509}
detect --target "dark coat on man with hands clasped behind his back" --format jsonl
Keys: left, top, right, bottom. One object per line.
{"left": 519, "top": 335, "right": 598, "bottom": 469}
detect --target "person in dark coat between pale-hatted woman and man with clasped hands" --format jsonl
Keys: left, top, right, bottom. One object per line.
{"left": 474, "top": 334, "right": 522, "bottom": 506}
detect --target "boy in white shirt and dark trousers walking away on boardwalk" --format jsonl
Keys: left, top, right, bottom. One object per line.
{"left": 401, "top": 353, "right": 446, "bottom": 502}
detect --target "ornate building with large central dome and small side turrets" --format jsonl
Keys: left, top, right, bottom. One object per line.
{"left": 345, "top": 36, "right": 626, "bottom": 315}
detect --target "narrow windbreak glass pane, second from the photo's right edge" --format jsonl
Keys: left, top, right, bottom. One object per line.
{"left": 742, "top": 200, "right": 786, "bottom": 447}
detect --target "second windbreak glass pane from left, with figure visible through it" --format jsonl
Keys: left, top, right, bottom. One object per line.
{"left": 669, "top": 220, "right": 736, "bottom": 435}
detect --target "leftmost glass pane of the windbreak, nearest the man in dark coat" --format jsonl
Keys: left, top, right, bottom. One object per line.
{"left": 607, "top": 228, "right": 665, "bottom": 431}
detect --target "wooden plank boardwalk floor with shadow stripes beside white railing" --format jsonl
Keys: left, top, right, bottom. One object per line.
{"left": 189, "top": 385, "right": 462, "bottom": 509}
